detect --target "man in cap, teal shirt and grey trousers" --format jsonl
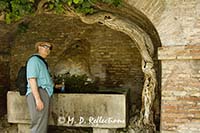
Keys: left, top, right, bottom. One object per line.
{"left": 26, "top": 42, "right": 54, "bottom": 133}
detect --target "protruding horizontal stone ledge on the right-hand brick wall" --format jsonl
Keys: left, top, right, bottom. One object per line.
{"left": 158, "top": 45, "right": 200, "bottom": 60}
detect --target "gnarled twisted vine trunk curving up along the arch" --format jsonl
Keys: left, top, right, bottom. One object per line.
{"left": 77, "top": 5, "right": 159, "bottom": 131}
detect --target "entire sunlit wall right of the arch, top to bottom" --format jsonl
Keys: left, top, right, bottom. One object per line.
{"left": 127, "top": 0, "right": 200, "bottom": 133}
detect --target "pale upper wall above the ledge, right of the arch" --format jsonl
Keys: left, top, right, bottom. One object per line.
{"left": 125, "top": 0, "right": 200, "bottom": 46}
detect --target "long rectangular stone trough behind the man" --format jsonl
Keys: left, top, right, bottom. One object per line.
{"left": 7, "top": 89, "right": 128, "bottom": 133}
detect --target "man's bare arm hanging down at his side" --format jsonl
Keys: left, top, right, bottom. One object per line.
{"left": 29, "top": 78, "right": 44, "bottom": 111}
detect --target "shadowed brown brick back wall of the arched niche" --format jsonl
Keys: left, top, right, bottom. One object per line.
{"left": 11, "top": 15, "right": 144, "bottom": 107}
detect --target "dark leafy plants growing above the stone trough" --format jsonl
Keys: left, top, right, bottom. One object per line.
{"left": 54, "top": 73, "right": 98, "bottom": 93}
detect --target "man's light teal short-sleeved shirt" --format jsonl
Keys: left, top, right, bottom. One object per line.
{"left": 26, "top": 56, "right": 54, "bottom": 96}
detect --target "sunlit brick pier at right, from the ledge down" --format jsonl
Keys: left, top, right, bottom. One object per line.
{"left": 158, "top": 45, "right": 200, "bottom": 133}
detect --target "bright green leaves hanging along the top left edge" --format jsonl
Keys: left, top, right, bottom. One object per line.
{"left": 0, "top": 0, "right": 122, "bottom": 23}
